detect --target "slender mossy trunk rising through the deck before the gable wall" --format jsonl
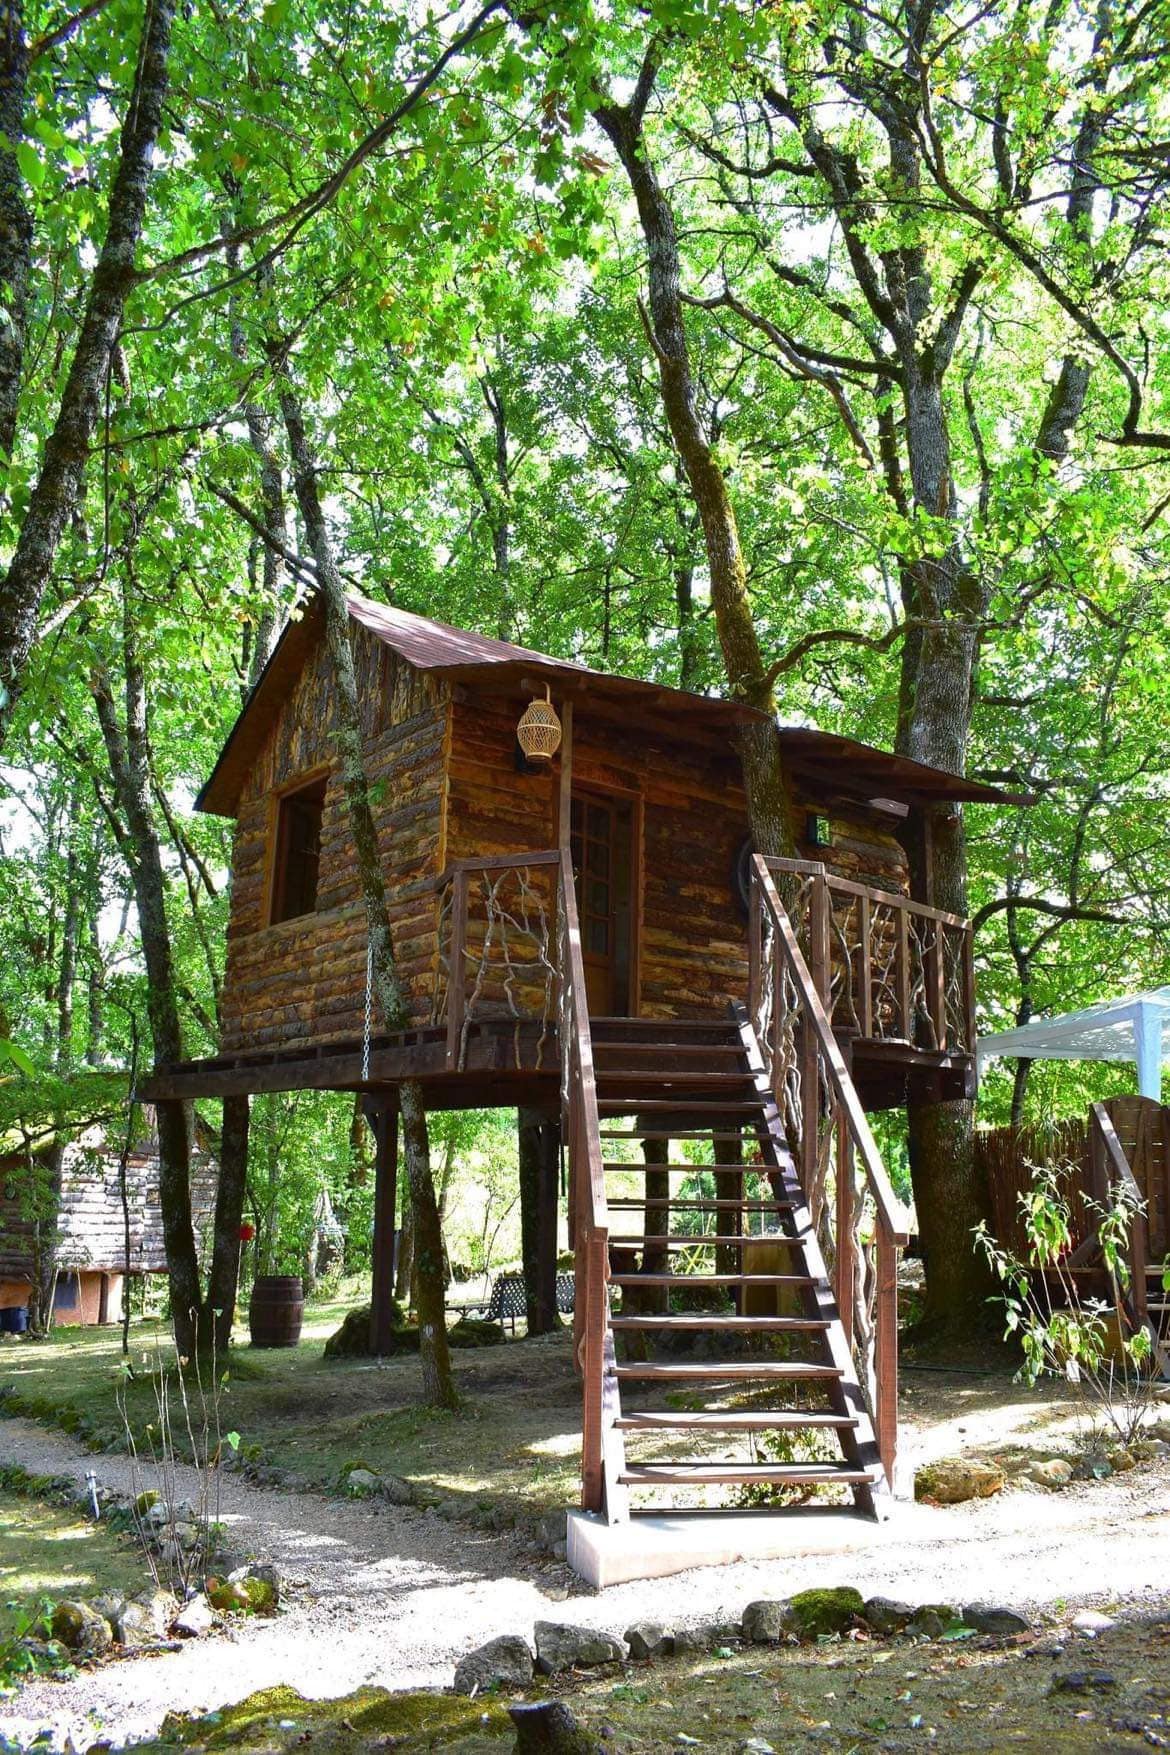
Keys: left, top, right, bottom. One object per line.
{"left": 277, "top": 373, "right": 456, "bottom": 1408}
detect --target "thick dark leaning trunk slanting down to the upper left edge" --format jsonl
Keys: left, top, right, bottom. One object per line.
{"left": 0, "top": 0, "right": 175, "bottom": 744}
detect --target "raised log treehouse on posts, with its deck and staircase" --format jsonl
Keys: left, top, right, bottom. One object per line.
{"left": 149, "top": 598, "right": 1002, "bottom": 1522}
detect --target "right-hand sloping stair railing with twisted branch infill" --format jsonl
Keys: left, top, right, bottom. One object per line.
{"left": 749, "top": 855, "right": 910, "bottom": 1485}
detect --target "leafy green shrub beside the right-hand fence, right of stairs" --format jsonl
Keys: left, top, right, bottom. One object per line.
{"left": 975, "top": 1165, "right": 1170, "bottom": 1444}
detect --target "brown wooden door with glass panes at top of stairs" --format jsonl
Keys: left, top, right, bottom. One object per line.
{"left": 570, "top": 792, "right": 631, "bottom": 1018}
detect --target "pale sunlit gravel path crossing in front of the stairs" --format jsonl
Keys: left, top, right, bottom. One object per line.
{"left": 0, "top": 1418, "right": 1170, "bottom": 1748}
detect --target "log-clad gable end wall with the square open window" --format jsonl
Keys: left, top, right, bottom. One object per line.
{"left": 221, "top": 628, "right": 449, "bottom": 1053}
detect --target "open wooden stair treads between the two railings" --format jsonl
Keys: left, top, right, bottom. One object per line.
{"left": 591, "top": 1018, "right": 886, "bottom": 1511}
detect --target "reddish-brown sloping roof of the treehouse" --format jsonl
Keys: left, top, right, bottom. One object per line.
{"left": 195, "top": 593, "right": 1028, "bottom": 816}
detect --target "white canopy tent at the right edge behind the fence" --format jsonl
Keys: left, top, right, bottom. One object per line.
{"left": 975, "top": 986, "right": 1170, "bottom": 1102}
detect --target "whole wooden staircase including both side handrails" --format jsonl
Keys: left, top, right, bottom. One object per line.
{"left": 558, "top": 855, "right": 907, "bottom": 1522}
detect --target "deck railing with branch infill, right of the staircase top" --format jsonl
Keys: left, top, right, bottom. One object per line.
{"left": 767, "top": 860, "right": 975, "bottom": 1055}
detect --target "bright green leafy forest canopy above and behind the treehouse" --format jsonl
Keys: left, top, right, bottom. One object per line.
{"left": 0, "top": 0, "right": 1170, "bottom": 1340}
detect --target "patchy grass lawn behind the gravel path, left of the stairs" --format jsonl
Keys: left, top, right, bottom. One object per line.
{"left": 0, "top": 1283, "right": 581, "bottom": 1513}
